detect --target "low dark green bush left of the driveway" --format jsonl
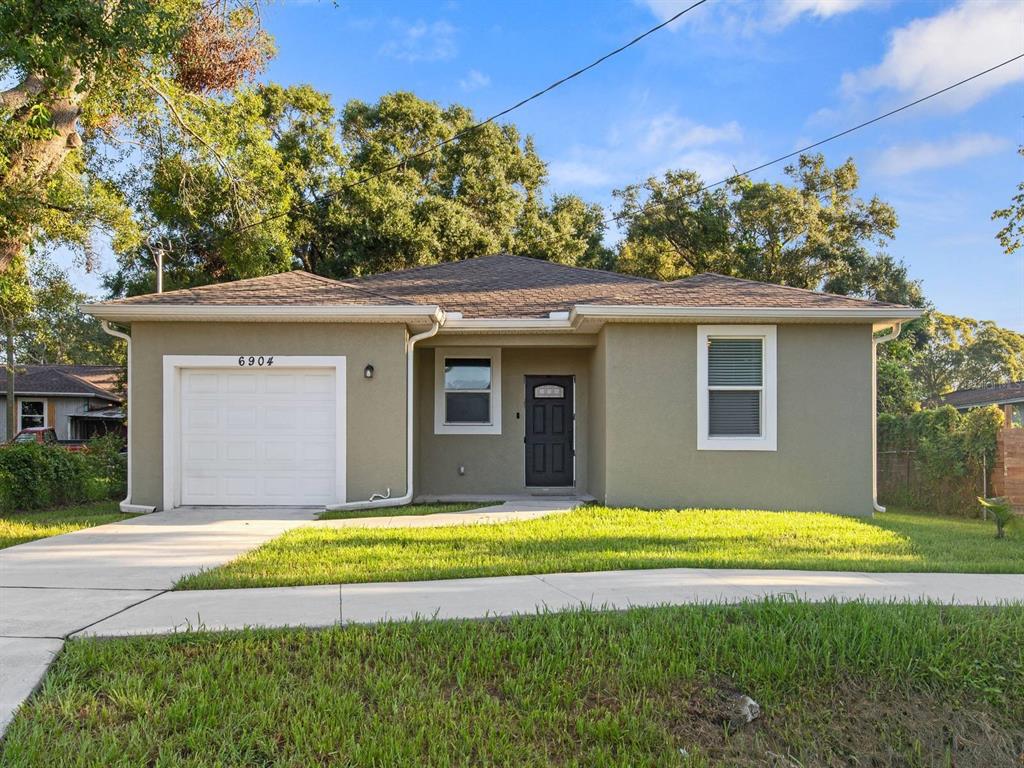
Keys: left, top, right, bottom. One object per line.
{"left": 0, "top": 435, "right": 127, "bottom": 513}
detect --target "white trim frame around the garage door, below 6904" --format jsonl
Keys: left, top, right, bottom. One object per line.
{"left": 161, "top": 354, "right": 348, "bottom": 510}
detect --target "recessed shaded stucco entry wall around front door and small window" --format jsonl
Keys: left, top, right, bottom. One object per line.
{"left": 416, "top": 340, "right": 591, "bottom": 497}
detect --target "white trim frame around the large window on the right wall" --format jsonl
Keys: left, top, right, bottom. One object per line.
{"left": 697, "top": 326, "right": 778, "bottom": 451}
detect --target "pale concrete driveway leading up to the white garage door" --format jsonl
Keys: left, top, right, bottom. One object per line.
{"left": 0, "top": 507, "right": 317, "bottom": 734}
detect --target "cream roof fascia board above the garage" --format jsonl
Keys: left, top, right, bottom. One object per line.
{"left": 79, "top": 304, "right": 444, "bottom": 323}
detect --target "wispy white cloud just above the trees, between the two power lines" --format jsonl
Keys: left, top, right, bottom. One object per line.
{"left": 549, "top": 113, "right": 743, "bottom": 189}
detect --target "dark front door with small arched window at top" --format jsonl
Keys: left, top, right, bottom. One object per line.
{"left": 526, "top": 376, "right": 574, "bottom": 487}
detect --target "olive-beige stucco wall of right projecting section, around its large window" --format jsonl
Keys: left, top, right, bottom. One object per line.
{"left": 592, "top": 325, "right": 871, "bottom": 515}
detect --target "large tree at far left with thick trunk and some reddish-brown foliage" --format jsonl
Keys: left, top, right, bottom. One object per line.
{"left": 0, "top": 0, "right": 270, "bottom": 434}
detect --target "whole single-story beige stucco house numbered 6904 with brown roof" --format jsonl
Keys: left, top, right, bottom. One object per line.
{"left": 84, "top": 255, "right": 920, "bottom": 515}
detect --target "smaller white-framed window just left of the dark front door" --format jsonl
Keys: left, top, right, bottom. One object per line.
{"left": 434, "top": 347, "right": 502, "bottom": 434}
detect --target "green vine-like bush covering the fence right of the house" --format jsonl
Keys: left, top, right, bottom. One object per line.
{"left": 879, "top": 406, "right": 1005, "bottom": 515}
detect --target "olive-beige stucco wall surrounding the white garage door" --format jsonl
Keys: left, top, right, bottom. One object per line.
{"left": 123, "top": 323, "right": 406, "bottom": 507}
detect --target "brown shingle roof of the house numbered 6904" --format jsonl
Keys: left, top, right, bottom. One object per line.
{"left": 86, "top": 254, "right": 907, "bottom": 318}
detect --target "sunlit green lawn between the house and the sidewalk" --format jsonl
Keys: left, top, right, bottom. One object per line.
{"left": 177, "top": 507, "right": 1024, "bottom": 589}
